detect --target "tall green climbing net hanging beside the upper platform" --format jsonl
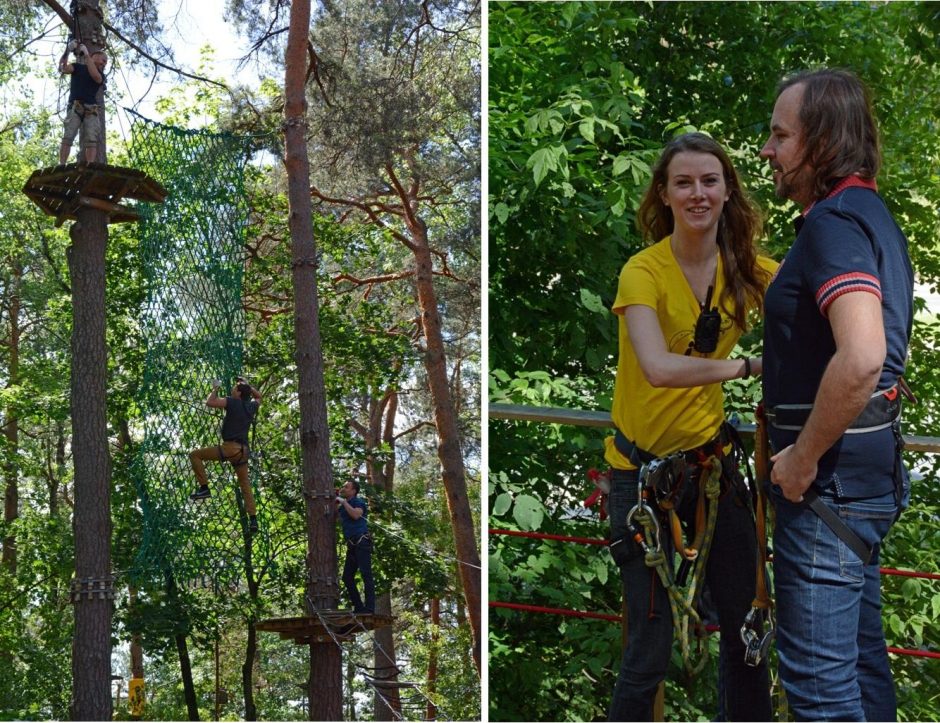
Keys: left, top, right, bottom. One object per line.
{"left": 130, "top": 117, "right": 268, "bottom": 589}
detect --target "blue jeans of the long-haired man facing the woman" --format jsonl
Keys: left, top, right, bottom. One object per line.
{"left": 770, "top": 486, "right": 897, "bottom": 721}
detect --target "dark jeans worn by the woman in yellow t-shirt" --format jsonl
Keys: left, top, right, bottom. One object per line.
{"left": 608, "top": 470, "right": 772, "bottom": 721}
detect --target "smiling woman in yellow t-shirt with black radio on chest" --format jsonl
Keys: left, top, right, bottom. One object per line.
{"left": 605, "top": 133, "right": 776, "bottom": 721}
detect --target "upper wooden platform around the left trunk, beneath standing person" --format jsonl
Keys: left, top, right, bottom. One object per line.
{"left": 23, "top": 163, "right": 167, "bottom": 226}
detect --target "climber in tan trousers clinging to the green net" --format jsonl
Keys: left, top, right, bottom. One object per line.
{"left": 189, "top": 377, "right": 261, "bottom": 534}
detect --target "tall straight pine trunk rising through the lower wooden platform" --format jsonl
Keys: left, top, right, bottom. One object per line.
{"left": 284, "top": 0, "right": 343, "bottom": 720}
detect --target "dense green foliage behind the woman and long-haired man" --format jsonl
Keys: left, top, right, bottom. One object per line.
{"left": 488, "top": 2, "right": 940, "bottom": 720}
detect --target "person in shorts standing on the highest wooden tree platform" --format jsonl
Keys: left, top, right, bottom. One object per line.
{"left": 59, "top": 40, "right": 108, "bottom": 164}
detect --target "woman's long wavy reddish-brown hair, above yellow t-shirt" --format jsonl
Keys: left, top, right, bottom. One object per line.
{"left": 636, "top": 133, "right": 770, "bottom": 331}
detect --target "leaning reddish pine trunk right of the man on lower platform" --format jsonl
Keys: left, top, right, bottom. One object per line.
{"left": 409, "top": 219, "right": 482, "bottom": 675}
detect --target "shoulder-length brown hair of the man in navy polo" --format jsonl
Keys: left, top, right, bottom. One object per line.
{"left": 777, "top": 68, "right": 881, "bottom": 199}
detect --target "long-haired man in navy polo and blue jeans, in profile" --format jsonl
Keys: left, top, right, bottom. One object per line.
{"left": 761, "top": 70, "right": 913, "bottom": 721}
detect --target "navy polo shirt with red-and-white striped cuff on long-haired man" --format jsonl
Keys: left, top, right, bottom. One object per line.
{"left": 762, "top": 187, "right": 914, "bottom": 497}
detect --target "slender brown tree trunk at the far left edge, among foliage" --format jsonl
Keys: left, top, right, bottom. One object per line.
{"left": 2, "top": 260, "right": 23, "bottom": 576}
